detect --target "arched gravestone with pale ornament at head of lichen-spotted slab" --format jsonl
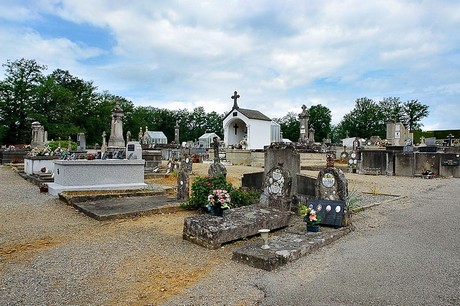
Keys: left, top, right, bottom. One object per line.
{"left": 260, "top": 163, "right": 292, "bottom": 211}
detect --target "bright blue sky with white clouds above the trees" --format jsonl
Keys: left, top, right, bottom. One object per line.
{"left": 0, "top": 0, "right": 460, "bottom": 130}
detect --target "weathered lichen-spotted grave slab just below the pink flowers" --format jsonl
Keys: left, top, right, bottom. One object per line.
{"left": 183, "top": 204, "right": 293, "bottom": 249}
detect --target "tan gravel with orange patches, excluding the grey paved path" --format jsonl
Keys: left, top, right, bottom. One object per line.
{"left": 0, "top": 164, "right": 452, "bottom": 305}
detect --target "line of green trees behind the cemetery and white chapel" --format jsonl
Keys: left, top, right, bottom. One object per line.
{"left": 0, "top": 59, "right": 429, "bottom": 145}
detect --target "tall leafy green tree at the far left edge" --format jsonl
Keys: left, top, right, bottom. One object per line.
{"left": 0, "top": 58, "right": 46, "bottom": 144}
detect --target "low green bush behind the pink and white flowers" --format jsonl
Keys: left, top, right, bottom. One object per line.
{"left": 186, "top": 175, "right": 234, "bottom": 209}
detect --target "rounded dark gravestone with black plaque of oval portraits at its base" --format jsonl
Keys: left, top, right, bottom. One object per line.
{"left": 307, "top": 154, "right": 349, "bottom": 227}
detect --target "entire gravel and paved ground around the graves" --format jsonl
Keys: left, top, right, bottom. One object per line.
{"left": 0, "top": 165, "right": 460, "bottom": 305}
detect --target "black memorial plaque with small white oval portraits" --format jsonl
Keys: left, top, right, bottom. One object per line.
{"left": 307, "top": 199, "right": 345, "bottom": 227}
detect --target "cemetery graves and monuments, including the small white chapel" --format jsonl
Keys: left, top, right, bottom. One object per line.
{"left": 2, "top": 92, "right": 460, "bottom": 304}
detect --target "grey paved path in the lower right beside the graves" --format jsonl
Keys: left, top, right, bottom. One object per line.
{"left": 255, "top": 179, "right": 460, "bottom": 305}
